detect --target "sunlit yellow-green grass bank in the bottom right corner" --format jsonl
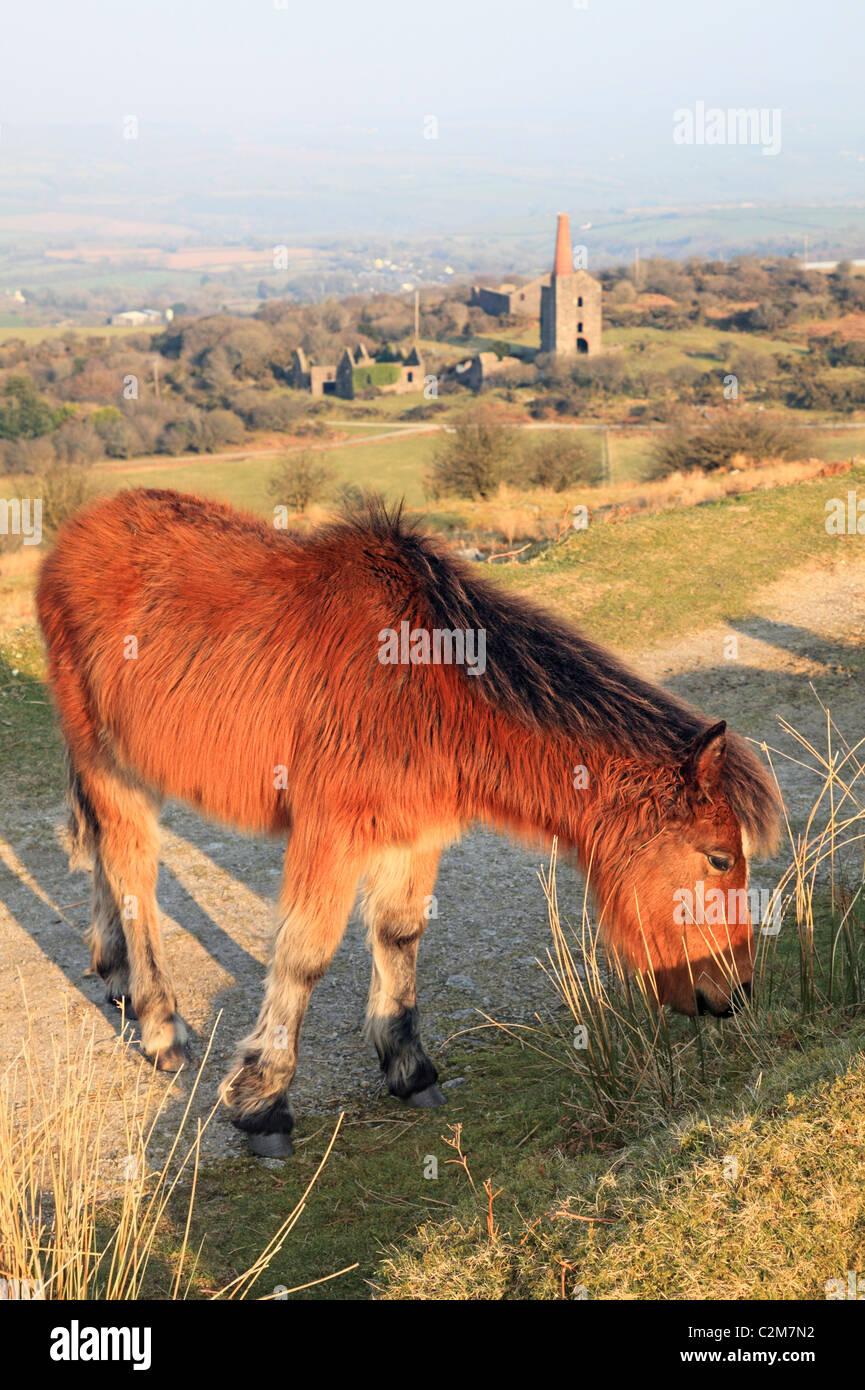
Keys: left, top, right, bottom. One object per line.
{"left": 380, "top": 1024, "right": 865, "bottom": 1301}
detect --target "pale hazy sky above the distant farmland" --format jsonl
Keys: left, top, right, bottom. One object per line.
{"left": 0, "top": 0, "right": 865, "bottom": 249}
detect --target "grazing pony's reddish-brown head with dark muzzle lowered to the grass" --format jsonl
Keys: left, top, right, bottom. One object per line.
{"left": 590, "top": 723, "right": 777, "bottom": 1017}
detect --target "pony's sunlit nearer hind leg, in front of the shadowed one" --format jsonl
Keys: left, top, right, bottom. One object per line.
{"left": 78, "top": 769, "right": 188, "bottom": 1072}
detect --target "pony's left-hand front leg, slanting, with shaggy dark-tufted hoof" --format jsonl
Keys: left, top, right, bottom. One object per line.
{"left": 221, "top": 827, "right": 362, "bottom": 1158}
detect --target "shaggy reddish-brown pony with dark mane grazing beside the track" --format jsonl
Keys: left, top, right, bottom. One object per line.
{"left": 39, "top": 491, "right": 777, "bottom": 1154}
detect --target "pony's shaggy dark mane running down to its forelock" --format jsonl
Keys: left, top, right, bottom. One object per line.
{"left": 328, "top": 498, "right": 779, "bottom": 852}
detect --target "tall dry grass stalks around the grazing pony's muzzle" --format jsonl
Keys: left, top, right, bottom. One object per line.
{"left": 542, "top": 705, "right": 865, "bottom": 1129}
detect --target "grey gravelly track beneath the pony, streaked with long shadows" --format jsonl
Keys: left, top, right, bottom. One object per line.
{"left": 0, "top": 560, "right": 865, "bottom": 1156}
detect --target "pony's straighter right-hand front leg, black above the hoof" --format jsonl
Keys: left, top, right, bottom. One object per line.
{"left": 364, "top": 848, "right": 444, "bottom": 1108}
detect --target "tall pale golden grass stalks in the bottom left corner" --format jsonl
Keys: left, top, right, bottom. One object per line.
{"left": 0, "top": 1001, "right": 353, "bottom": 1301}
